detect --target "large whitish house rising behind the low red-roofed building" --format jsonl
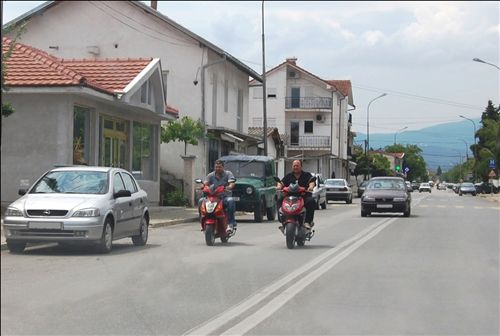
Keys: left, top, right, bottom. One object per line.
{"left": 5, "top": 1, "right": 262, "bottom": 205}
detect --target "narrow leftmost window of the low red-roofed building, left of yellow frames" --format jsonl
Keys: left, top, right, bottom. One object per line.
{"left": 73, "top": 106, "right": 90, "bottom": 164}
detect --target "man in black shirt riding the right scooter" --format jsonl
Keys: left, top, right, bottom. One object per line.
{"left": 276, "top": 160, "right": 316, "bottom": 232}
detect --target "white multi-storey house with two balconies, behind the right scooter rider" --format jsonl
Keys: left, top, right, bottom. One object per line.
{"left": 249, "top": 58, "right": 355, "bottom": 180}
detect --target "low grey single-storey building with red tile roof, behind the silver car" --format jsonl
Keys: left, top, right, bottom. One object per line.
{"left": 1, "top": 38, "right": 171, "bottom": 203}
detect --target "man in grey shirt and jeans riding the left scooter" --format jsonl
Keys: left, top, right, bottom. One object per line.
{"left": 203, "top": 160, "right": 236, "bottom": 233}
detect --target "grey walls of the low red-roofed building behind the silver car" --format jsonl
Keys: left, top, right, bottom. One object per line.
{"left": 1, "top": 93, "right": 160, "bottom": 205}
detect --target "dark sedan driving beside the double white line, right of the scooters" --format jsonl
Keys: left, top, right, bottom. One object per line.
{"left": 361, "top": 177, "right": 411, "bottom": 217}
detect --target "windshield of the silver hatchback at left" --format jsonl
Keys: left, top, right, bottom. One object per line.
{"left": 30, "top": 171, "right": 108, "bottom": 194}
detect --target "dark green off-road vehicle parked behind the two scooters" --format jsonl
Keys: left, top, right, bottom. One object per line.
{"left": 220, "top": 155, "right": 278, "bottom": 222}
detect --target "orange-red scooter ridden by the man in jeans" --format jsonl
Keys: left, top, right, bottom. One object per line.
{"left": 195, "top": 179, "right": 235, "bottom": 246}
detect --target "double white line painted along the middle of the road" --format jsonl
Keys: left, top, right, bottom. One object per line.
{"left": 184, "top": 218, "right": 398, "bottom": 335}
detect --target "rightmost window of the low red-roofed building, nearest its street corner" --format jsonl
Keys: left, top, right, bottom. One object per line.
{"left": 132, "top": 121, "right": 157, "bottom": 180}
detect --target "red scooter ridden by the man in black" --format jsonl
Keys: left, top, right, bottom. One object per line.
{"left": 275, "top": 177, "right": 314, "bottom": 249}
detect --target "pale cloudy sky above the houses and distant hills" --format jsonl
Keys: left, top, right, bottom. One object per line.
{"left": 2, "top": 1, "right": 500, "bottom": 138}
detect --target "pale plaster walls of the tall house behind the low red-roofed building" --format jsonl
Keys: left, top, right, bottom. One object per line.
{"left": 8, "top": 1, "right": 254, "bottom": 189}
